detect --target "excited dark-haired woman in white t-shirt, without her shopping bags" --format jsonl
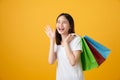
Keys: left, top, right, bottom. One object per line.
{"left": 46, "top": 13, "right": 83, "bottom": 80}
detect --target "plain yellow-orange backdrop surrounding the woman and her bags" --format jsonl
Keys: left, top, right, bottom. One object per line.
{"left": 0, "top": 0, "right": 120, "bottom": 80}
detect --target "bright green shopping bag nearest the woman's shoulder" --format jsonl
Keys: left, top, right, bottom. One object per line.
{"left": 81, "top": 37, "right": 98, "bottom": 71}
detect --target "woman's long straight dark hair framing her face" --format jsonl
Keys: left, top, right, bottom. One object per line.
{"left": 55, "top": 13, "right": 75, "bottom": 45}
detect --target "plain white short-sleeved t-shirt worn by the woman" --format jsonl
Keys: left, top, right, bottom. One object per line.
{"left": 55, "top": 36, "right": 83, "bottom": 80}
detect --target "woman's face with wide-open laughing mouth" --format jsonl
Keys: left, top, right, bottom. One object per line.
{"left": 56, "top": 16, "right": 70, "bottom": 35}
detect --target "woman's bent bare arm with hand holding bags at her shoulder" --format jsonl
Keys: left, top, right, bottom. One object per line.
{"left": 64, "top": 34, "right": 81, "bottom": 66}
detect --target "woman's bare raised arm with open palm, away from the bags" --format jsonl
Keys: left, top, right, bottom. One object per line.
{"left": 45, "top": 26, "right": 57, "bottom": 64}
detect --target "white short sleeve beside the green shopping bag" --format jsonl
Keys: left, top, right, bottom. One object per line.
{"left": 70, "top": 35, "right": 82, "bottom": 51}
